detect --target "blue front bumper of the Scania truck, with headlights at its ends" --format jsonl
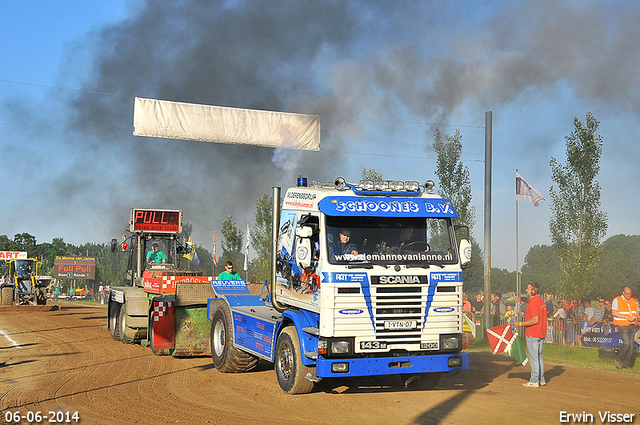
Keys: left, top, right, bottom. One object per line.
{"left": 316, "top": 353, "right": 469, "bottom": 378}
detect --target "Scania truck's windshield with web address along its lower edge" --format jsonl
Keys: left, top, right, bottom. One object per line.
{"left": 326, "top": 216, "right": 457, "bottom": 266}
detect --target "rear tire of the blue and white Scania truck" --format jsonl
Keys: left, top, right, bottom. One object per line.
{"left": 209, "top": 304, "right": 258, "bottom": 373}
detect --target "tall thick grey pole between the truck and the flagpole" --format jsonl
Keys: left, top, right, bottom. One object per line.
{"left": 484, "top": 111, "right": 493, "bottom": 338}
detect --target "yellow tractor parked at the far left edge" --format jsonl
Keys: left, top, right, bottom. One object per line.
{"left": 0, "top": 258, "right": 51, "bottom": 305}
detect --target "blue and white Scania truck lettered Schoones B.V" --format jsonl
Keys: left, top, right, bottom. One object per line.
{"left": 207, "top": 178, "right": 471, "bottom": 394}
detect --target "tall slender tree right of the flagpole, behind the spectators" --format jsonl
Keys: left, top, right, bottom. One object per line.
{"left": 549, "top": 112, "right": 607, "bottom": 299}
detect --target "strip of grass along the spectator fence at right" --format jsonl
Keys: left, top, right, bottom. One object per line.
{"left": 467, "top": 338, "right": 640, "bottom": 374}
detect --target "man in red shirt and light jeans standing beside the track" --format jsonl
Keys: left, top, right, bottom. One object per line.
{"left": 518, "top": 282, "right": 547, "bottom": 388}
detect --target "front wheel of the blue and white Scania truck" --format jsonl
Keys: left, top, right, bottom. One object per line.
{"left": 274, "top": 326, "right": 313, "bottom": 394}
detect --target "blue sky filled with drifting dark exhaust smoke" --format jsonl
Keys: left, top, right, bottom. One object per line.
{"left": 0, "top": 0, "right": 640, "bottom": 270}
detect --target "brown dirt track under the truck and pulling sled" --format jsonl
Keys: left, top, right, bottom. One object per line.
{"left": 0, "top": 302, "right": 640, "bottom": 425}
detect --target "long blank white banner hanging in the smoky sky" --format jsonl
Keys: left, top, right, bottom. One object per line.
{"left": 133, "top": 97, "right": 320, "bottom": 151}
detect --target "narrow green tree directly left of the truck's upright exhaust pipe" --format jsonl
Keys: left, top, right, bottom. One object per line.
{"left": 250, "top": 193, "right": 273, "bottom": 282}
